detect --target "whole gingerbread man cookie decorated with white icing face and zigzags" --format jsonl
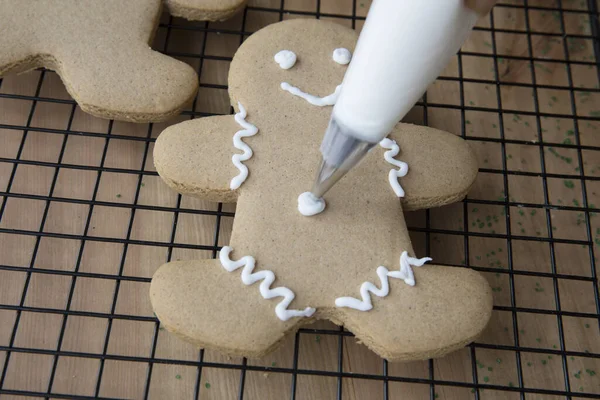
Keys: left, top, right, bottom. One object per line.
{"left": 150, "top": 19, "right": 492, "bottom": 360}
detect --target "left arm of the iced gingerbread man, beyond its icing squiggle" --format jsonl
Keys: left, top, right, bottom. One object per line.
{"left": 154, "top": 115, "right": 240, "bottom": 203}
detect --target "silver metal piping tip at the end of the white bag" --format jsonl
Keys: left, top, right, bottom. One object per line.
{"left": 311, "top": 118, "right": 376, "bottom": 198}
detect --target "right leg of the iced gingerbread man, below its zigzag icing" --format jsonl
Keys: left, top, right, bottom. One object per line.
{"left": 333, "top": 264, "right": 492, "bottom": 361}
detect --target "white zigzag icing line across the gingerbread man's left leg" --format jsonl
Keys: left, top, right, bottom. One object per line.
{"left": 219, "top": 246, "right": 315, "bottom": 321}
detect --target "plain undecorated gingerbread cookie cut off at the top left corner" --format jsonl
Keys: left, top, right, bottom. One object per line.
{"left": 0, "top": 0, "right": 198, "bottom": 122}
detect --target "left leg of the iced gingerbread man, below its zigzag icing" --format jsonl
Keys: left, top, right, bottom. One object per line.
{"left": 150, "top": 259, "right": 311, "bottom": 357}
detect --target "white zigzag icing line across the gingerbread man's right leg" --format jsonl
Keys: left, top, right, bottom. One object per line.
{"left": 335, "top": 251, "right": 431, "bottom": 311}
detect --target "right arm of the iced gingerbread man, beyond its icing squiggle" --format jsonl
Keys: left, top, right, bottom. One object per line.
{"left": 380, "top": 124, "right": 477, "bottom": 211}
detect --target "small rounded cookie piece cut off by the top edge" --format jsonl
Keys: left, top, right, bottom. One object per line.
{"left": 165, "top": 0, "right": 246, "bottom": 21}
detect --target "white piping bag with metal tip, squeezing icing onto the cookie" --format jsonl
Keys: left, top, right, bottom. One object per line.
{"left": 311, "top": 0, "right": 495, "bottom": 198}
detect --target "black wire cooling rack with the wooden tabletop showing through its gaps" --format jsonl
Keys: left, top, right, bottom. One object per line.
{"left": 0, "top": 0, "right": 600, "bottom": 399}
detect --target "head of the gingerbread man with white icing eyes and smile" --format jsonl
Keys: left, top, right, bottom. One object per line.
{"left": 229, "top": 20, "right": 358, "bottom": 113}
